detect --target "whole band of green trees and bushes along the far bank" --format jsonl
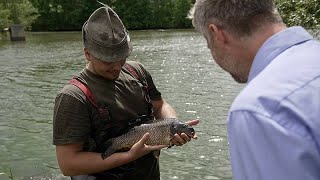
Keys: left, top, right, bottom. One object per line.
{"left": 0, "top": 0, "right": 320, "bottom": 33}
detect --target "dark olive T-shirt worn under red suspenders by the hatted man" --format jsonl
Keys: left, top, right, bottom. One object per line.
{"left": 53, "top": 62, "right": 161, "bottom": 180}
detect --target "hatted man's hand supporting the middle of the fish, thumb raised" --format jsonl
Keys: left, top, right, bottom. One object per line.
{"left": 128, "top": 133, "right": 168, "bottom": 160}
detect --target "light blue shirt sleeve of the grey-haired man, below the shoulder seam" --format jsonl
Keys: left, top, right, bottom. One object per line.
{"left": 228, "top": 111, "right": 320, "bottom": 180}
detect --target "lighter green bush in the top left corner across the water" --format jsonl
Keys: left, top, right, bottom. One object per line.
{"left": 0, "top": 0, "right": 38, "bottom": 30}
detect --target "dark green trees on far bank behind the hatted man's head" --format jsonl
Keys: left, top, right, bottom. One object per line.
{"left": 29, "top": 0, "right": 195, "bottom": 31}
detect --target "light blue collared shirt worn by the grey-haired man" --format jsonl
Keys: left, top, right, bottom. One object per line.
{"left": 228, "top": 27, "right": 320, "bottom": 180}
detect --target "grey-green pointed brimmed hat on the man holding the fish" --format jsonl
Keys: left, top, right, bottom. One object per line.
{"left": 82, "top": 6, "right": 132, "bottom": 62}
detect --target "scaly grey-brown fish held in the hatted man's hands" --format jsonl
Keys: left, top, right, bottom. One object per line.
{"left": 101, "top": 118, "right": 195, "bottom": 159}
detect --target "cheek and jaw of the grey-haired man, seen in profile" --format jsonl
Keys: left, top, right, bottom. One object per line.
{"left": 205, "top": 25, "right": 248, "bottom": 83}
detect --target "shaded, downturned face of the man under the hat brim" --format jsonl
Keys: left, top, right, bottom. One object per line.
{"left": 85, "top": 50, "right": 126, "bottom": 80}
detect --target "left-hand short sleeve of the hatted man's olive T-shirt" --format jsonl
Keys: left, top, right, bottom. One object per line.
{"left": 53, "top": 85, "right": 91, "bottom": 145}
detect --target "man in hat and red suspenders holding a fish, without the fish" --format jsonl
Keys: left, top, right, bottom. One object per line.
{"left": 53, "top": 6, "right": 198, "bottom": 180}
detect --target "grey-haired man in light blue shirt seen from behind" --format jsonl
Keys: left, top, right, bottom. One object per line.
{"left": 189, "top": 0, "right": 320, "bottom": 180}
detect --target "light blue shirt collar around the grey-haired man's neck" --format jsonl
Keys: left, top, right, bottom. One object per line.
{"left": 248, "top": 26, "right": 313, "bottom": 82}
